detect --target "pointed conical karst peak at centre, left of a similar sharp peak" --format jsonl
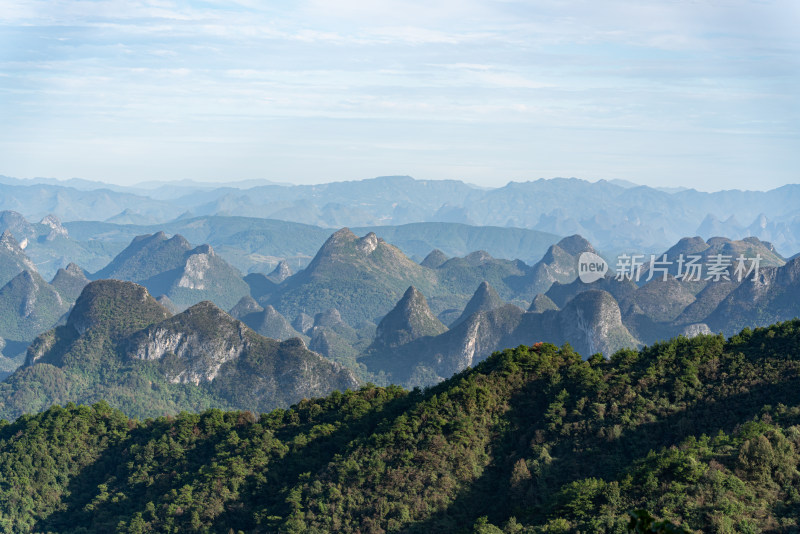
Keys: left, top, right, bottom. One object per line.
{"left": 372, "top": 286, "right": 447, "bottom": 351}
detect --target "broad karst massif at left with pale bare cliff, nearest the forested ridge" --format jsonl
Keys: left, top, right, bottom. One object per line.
{"left": 9, "top": 280, "right": 359, "bottom": 420}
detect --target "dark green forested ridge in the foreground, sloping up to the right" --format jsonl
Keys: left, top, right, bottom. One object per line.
{"left": 0, "top": 320, "right": 800, "bottom": 533}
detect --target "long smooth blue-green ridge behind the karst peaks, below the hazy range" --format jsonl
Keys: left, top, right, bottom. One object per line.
{"left": 0, "top": 211, "right": 560, "bottom": 278}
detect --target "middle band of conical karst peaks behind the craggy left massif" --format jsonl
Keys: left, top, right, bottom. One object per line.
{"left": 0, "top": 210, "right": 800, "bottom": 398}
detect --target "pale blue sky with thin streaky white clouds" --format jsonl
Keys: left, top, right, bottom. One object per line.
{"left": 0, "top": 0, "right": 800, "bottom": 191}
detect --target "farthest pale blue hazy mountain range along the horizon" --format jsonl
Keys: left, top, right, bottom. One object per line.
{"left": 0, "top": 176, "right": 800, "bottom": 255}
